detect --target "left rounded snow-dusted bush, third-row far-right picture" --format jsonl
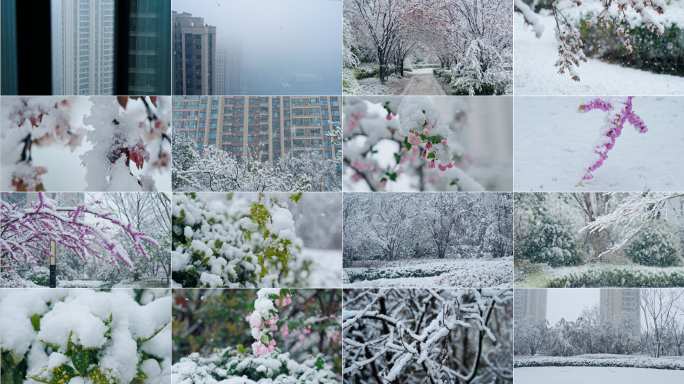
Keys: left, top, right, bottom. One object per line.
{"left": 516, "top": 215, "right": 584, "bottom": 267}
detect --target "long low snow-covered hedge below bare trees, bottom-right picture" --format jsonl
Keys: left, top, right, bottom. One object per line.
{"left": 514, "top": 354, "right": 684, "bottom": 372}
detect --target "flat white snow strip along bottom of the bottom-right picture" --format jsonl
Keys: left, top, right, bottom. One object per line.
{"left": 513, "top": 367, "right": 684, "bottom": 384}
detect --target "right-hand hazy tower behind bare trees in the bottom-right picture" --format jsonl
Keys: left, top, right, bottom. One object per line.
{"left": 600, "top": 288, "right": 641, "bottom": 337}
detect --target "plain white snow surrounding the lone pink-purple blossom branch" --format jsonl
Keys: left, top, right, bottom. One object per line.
{"left": 514, "top": 97, "right": 684, "bottom": 192}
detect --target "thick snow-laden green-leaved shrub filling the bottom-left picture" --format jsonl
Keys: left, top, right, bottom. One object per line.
{"left": 0, "top": 289, "right": 171, "bottom": 384}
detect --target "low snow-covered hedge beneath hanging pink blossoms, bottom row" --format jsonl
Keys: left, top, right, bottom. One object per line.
{"left": 172, "top": 346, "right": 339, "bottom": 384}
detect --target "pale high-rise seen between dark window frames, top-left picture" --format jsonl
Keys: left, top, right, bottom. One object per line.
{"left": 53, "top": 0, "right": 115, "bottom": 95}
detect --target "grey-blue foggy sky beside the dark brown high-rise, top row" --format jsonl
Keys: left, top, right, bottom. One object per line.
{"left": 173, "top": 0, "right": 342, "bottom": 94}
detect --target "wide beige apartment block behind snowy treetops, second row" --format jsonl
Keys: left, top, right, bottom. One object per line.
{"left": 173, "top": 96, "right": 341, "bottom": 162}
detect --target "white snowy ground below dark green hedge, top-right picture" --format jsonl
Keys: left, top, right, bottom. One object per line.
{"left": 514, "top": 13, "right": 684, "bottom": 95}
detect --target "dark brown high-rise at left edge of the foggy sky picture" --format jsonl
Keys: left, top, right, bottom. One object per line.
{"left": 172, "top": 11, "right": 217, "bottom": 95}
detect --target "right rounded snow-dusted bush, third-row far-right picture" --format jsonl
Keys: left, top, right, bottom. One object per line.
{"left": 624, "top": 220, "right": 682, "bottom": 267}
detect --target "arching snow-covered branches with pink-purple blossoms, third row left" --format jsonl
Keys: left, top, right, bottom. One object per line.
{"left": 0, "top": 193, "right": 159, "bottom": 269}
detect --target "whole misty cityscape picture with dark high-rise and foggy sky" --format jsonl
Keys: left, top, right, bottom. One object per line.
{"left": 172, "top": 0, "right": 342, "bottom": 95}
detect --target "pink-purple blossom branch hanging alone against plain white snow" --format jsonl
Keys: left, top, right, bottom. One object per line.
{"left": 575, "top": 96, "right": 648, "bottom": 187}
